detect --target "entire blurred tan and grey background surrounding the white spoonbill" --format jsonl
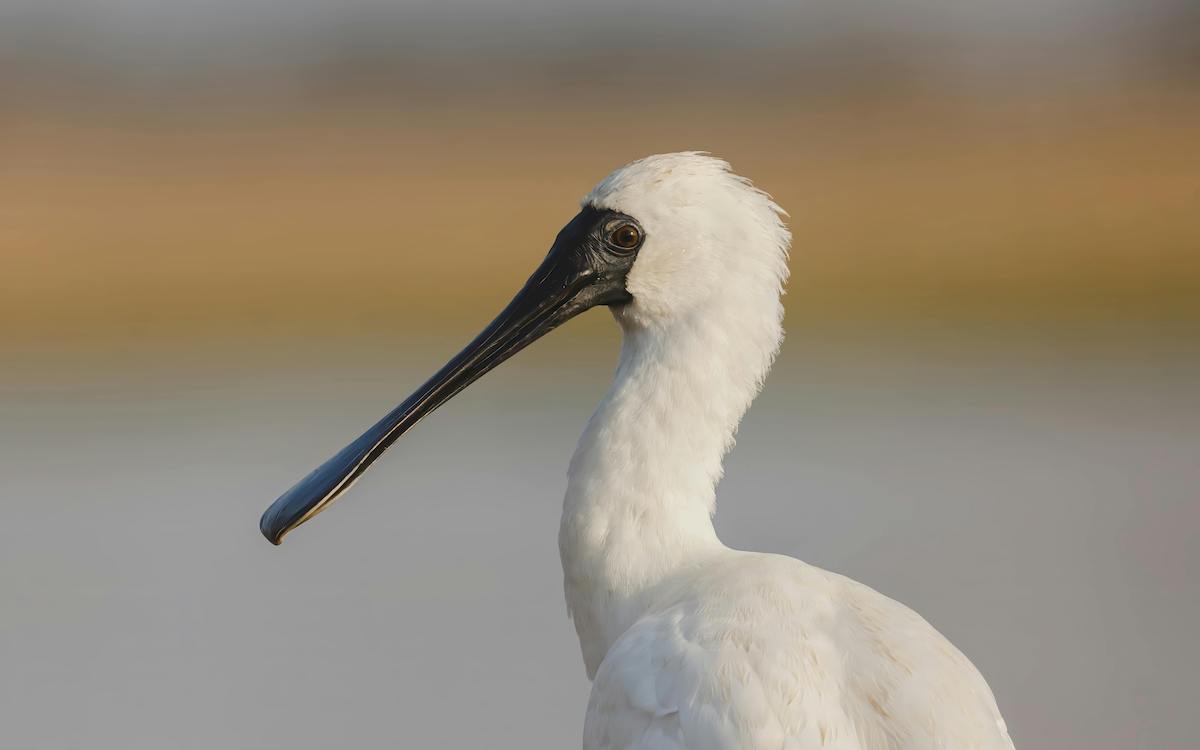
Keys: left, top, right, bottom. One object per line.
{"left": 0, "top": 0, "right": 1200, "bottom": 750}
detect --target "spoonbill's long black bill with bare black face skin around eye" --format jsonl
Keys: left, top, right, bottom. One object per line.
{"left": 259, "top": 206, "right": 646, "bottom": 545}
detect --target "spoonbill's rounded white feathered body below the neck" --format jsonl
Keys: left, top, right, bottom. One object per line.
{"left": 583, "top": 550, "right": 1013, "bottom": 750}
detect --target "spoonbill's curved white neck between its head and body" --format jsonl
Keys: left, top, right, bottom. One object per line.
{"left": 559, "top": 300, "right": 781, "bottom": 677}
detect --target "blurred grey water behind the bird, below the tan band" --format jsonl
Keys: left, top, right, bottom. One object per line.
{"left": 0, "top": 332, "right": 1200, "bottom": 750}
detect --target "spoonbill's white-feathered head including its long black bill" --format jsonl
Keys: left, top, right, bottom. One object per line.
{"left": 259, "top": 152, "right": 790, "bottom": 544}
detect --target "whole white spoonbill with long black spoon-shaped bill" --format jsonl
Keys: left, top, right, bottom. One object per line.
{"left": 262, "top": 152, "right": 1013, "bottom": 750}
